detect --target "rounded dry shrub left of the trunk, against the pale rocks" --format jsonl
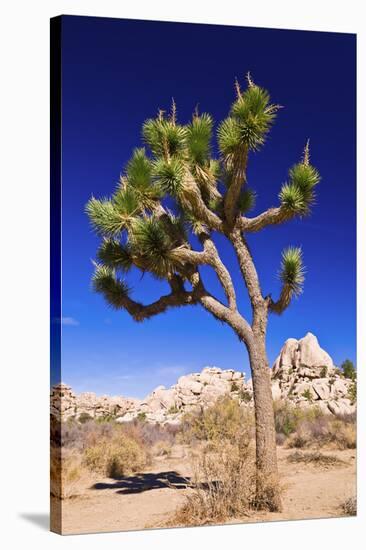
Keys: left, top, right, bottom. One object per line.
{"left": 181, "top": 396, "right": 253, "bottom": 443}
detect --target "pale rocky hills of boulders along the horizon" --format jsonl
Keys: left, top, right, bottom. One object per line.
{"left": 51, "top": 333, "right": 356, "bottom": 424}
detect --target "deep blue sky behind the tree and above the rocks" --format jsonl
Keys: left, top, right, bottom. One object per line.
{"left": 53, "top": 16, "right": 356, "bottom": 396}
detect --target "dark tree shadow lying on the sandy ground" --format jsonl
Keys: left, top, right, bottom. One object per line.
{"left": 91, "top": 471, "right": 190, "bottom": 495}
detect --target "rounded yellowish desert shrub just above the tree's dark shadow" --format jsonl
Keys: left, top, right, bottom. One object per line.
{"left": 84, "top": 434, "right": 148, "bottom": 477}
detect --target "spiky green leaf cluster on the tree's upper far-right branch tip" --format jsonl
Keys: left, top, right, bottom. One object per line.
{"left": 279, "top": 162, "right": 320, "bottom": 215}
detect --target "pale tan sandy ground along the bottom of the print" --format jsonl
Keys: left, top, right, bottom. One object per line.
{"left": 58, "top": 447, "right": 356, "bottom": 534}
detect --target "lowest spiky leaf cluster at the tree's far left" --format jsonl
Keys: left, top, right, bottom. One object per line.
{"left": 92, "top": 264, "right": 129, "bottom": 309}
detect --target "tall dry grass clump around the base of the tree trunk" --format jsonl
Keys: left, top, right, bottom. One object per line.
{"left": 169, "top": 397, "right": 280, "bottom": 525}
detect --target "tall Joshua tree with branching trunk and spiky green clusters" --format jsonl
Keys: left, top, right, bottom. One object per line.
{"left": 86, "top": 74, "right": 320, "bottom": 510}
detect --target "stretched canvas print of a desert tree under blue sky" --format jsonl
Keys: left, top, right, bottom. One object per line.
{"left": 50, "top": 16, "right": 357, "bottom": 534}
